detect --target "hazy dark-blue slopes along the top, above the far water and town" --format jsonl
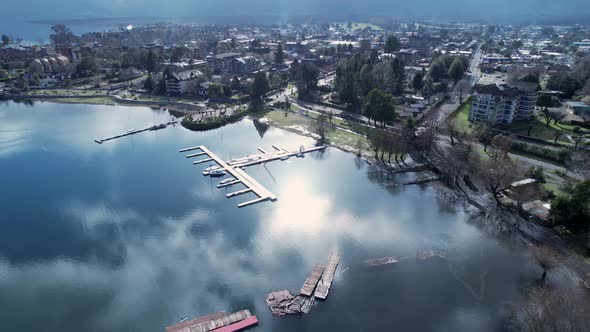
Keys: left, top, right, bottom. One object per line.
{"left": 0, "top": 0, "right": 590, "bottom": 23}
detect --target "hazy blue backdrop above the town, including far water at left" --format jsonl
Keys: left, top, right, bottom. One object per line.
{"left": 0, "top": 0, "right": 590, "bottom": 42}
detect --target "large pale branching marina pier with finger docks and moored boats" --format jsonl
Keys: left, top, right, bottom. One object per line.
{"left": 178, "top": 145, "right": 326, "bottom": 207}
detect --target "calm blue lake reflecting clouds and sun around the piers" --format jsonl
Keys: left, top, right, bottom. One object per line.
{"left": 0, "top": 102, "right": 535, "bottom": 332}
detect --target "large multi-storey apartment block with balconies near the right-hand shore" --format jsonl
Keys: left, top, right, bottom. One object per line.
{"left": 469, "top": 82, "right": 538, "bottom": 125}
